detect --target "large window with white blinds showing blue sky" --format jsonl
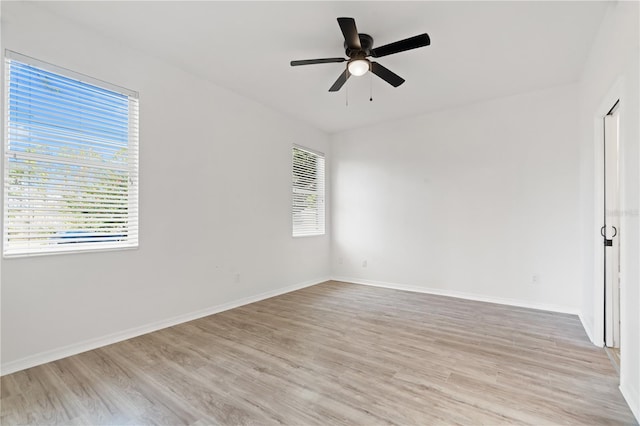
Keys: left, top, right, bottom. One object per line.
{"left": 3, "top": 51, "right": 138, "bottom": 256}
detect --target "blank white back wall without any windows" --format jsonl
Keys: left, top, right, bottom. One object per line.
{"left": 332, "top": 85, "right": 581, "bottom": 312}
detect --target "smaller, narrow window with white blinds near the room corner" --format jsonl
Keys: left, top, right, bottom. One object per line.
{"left": 292, "top": 146, "right": 324, "bottom": 237}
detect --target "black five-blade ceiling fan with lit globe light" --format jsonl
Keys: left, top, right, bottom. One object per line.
{"left": 291, "top": 18, "right": 431, "bottom": 92}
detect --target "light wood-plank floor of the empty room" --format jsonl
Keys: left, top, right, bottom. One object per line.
{"left": 0, "top": 282, "right": 635, "bottom": 425}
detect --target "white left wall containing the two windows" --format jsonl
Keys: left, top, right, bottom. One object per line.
{"left": 1, "top": 2, "right": 331, "bottom": 373}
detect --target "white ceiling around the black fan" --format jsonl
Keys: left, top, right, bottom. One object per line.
{"left": 31, "top": 1, "right": 607, "bottom": 133}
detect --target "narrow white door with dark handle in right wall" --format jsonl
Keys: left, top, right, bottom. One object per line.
{"left": 601, "top": 104, "right": 621, "bottom": 348}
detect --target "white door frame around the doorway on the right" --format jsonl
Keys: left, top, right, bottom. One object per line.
{"left": 591, "top": 78, "right": 625, "bottom": 347}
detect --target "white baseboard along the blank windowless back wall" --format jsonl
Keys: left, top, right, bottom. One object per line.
{"left": 332, "top": 277, "right": 580, "bottom": 315}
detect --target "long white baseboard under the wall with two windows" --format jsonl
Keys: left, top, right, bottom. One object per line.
{"left": 0, "top": 277, "right": 330, "bottom": 376}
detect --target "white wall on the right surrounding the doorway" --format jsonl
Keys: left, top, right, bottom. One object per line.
{"left": 580, "top": 2, "right": 640, "bottom": 419}
